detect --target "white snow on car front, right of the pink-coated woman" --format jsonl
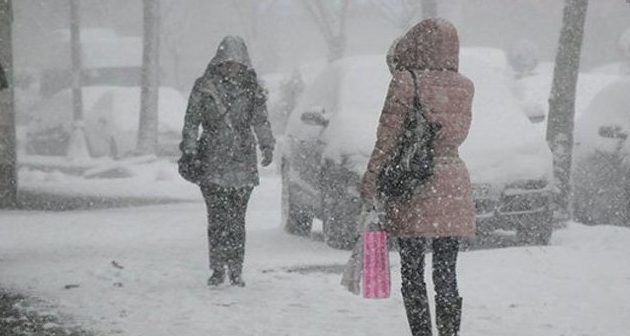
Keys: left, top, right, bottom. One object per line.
{"left": 460, "top": 57, "right": 552, "bottom": 183}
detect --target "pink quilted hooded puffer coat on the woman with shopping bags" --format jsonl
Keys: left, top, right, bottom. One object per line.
{"left": 362, "top": 19, "right": 475, "bottom": 238}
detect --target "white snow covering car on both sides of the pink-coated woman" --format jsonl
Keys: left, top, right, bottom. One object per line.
{"left": 314, "top": 55, "right": 551, "bottom": 184}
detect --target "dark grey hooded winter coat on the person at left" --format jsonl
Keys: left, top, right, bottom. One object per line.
{"left": 180, "top": 36, "right": 275, "bottom": 188}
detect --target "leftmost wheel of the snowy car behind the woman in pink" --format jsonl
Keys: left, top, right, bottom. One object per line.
{"left": 280, "top": 159, "right": 313, "bottom": 236}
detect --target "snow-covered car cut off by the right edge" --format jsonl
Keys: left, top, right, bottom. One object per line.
{"left": 572, "top": 78, "right": 630, "bottom": 225}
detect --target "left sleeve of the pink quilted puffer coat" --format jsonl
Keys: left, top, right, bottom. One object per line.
{"left": 361, "top": 71, "right": 414, "bottom": 199}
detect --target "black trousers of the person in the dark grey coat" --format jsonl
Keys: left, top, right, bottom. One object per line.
{"left": 201, "top": 184, "right": 253, "bottom": 275}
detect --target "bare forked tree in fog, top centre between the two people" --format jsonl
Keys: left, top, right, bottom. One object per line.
{"left": 301, "top": 0, "right": 348, "bottom": 62}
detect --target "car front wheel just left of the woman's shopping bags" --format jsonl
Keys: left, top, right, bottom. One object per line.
{"left": 323, "top": 195, "right": 361, "bottom": 250}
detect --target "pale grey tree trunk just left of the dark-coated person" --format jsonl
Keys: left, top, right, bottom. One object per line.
{"left": 136, "top": 0, "right": 160, "bottom": 155}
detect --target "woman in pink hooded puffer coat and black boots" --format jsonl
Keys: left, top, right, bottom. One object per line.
{"left": 362, "top": 19, "right": 475, "bottom": 336}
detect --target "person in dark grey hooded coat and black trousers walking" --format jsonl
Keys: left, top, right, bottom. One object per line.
{"left": 180, "top": 36, "right": 275, "bottom": 287}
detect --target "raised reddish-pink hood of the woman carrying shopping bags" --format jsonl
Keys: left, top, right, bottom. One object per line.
{"left": 394, "top": 18, "right": 459, "bottom": 71}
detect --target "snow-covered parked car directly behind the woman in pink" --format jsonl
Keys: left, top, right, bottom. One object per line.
{"left": 281, "top": 50, "right": 552, "bottom": 248}
